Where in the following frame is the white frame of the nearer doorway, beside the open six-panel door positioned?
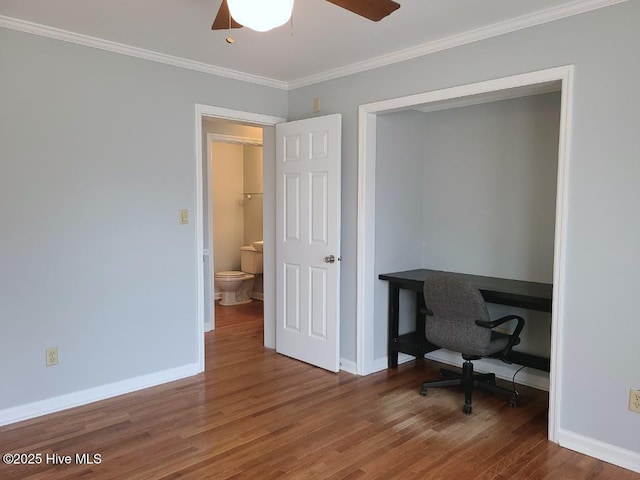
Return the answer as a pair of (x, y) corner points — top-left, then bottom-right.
(194, 104), (286, 372)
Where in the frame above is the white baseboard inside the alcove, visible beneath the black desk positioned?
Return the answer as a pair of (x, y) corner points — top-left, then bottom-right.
(373, 349), (549, 392)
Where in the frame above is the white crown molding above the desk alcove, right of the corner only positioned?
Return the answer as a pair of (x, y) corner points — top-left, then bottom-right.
(287, 0), (628, 90)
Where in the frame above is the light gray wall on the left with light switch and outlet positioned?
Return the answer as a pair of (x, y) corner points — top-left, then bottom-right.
(0, 29), (287, 410)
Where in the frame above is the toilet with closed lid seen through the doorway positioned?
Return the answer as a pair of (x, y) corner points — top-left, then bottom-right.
(213, 246), (262, 306)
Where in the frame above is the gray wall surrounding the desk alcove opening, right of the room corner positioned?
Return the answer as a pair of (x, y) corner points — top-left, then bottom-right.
(289, 1), (640, 452)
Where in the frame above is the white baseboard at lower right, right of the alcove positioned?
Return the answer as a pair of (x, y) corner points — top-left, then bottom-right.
(558, 428), (640, 473)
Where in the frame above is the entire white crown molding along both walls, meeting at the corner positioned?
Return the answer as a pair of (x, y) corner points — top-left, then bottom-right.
(0, 0), (628, 90)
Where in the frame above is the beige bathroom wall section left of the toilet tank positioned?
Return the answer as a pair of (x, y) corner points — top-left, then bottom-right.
(210, 142), (244, 272)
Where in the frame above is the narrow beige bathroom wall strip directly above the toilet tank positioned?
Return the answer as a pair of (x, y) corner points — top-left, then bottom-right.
(244, 145), (263, 245)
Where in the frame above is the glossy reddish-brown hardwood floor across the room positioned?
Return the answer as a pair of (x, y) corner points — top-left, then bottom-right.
(0, 302), (640, 480)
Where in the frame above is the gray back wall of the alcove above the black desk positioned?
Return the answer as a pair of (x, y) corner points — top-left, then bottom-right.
(422, 93), (560, 283)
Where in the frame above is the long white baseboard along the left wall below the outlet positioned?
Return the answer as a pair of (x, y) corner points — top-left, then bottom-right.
(0, 363), (200, 426)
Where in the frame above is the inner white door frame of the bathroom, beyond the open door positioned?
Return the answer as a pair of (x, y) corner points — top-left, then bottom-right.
(208, 133), (264, 332)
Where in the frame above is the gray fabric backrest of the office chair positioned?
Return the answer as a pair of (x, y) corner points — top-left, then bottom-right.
(424, 274), (491, 354)
